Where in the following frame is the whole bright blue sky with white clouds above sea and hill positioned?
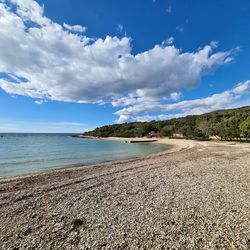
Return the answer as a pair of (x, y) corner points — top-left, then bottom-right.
(0, 0), (250, 133)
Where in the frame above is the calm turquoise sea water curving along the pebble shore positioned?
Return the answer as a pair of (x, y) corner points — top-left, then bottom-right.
(0, 134), (169, 177)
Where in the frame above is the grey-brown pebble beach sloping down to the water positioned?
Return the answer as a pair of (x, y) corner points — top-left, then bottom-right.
(0, 142), (250, 250)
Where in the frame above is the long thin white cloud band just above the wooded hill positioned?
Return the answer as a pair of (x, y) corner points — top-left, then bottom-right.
(115, 80), (250, 123)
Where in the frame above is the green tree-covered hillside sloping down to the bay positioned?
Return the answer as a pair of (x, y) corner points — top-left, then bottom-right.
(84, 106), (250, 140)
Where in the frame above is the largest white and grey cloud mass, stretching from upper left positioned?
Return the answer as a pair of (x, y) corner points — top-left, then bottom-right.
(0, 0), (245, 121)
